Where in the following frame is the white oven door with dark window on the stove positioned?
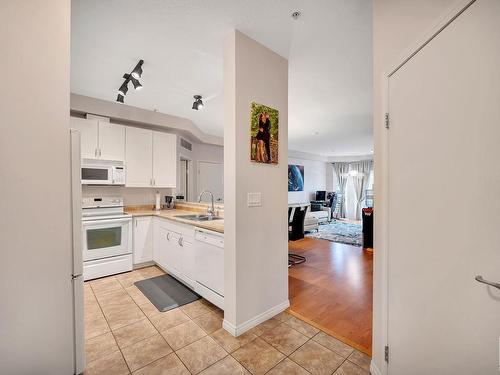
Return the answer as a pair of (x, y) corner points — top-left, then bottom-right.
(82, 217), (132, 261)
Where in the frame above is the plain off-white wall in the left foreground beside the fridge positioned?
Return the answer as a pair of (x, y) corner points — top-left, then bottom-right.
(0, 0), (73, 375)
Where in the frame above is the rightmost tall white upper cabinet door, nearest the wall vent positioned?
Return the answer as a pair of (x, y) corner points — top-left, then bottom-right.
(153, 131), (177, 188)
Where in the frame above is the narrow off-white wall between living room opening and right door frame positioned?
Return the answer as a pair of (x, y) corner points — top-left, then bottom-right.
(373, 0), (461, 373)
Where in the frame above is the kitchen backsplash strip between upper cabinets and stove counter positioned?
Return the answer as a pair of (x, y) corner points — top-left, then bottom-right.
(82, 185), (175, 206)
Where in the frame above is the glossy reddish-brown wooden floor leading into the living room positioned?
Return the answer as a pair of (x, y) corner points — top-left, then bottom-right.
(289, 238), (373, 355)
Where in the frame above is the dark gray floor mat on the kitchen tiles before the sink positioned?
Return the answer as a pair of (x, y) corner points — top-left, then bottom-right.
(134, 275), (200, 312)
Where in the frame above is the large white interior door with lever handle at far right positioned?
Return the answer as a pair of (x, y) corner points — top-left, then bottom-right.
(388, 0), (500, 375)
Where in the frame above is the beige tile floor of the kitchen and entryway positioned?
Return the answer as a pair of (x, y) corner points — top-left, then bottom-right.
(85, 267), (370, 375)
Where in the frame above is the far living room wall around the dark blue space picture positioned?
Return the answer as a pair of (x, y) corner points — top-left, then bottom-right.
(288, 158), (333, 203)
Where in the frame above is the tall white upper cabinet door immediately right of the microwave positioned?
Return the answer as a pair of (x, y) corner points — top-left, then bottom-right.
(125, 126), (153, 187)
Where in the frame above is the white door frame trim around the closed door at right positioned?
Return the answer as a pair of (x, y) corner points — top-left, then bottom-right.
(376, 0), (480, 375)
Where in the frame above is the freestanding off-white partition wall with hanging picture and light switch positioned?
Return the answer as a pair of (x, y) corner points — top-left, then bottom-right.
(224, 31), (289, 334)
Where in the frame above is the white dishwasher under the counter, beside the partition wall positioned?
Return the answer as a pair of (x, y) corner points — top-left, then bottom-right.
(194, 228), (224, 300)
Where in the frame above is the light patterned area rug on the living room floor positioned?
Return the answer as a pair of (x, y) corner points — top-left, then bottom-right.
(306, 220), (363, 246)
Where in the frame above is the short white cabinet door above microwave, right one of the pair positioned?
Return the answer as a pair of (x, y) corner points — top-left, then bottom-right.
(99, 122), (125, 161)
